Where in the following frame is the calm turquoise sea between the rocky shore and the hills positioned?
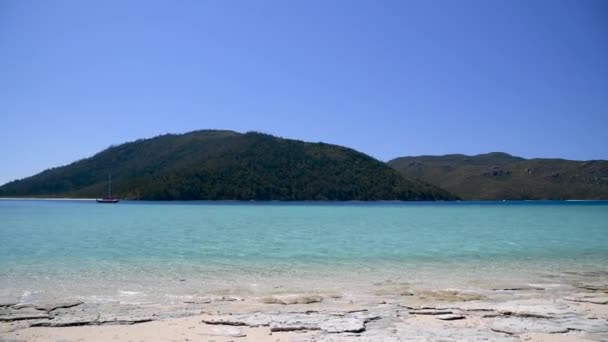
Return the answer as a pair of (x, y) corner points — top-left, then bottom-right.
(0, 200), (608, 303)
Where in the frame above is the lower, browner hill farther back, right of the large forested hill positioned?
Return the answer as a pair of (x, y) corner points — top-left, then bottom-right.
(388, 152), (608, 200)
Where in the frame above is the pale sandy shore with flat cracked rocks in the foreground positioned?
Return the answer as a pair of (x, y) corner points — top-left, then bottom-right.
(0, 276), (608, 342)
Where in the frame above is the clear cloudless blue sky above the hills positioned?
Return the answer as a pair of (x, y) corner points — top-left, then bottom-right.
(0, 0), (608, 183)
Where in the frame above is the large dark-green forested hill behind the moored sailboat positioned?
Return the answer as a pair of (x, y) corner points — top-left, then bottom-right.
(0, 130), (454, 200)
